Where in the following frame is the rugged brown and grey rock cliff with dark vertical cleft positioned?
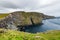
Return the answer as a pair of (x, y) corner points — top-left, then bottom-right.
(0, 11), (54, 30)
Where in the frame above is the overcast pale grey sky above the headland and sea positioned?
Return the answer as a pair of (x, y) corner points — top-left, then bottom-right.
(0, 0), (60, 16)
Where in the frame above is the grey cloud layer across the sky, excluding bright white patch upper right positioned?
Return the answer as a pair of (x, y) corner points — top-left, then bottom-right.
(0, 0), (60, 16)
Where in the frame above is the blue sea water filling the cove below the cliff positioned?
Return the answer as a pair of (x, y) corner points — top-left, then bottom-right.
(25, 19), (60, 33)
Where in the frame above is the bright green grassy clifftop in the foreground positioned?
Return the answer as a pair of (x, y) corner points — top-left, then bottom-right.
(0, 29), (60, 40)
